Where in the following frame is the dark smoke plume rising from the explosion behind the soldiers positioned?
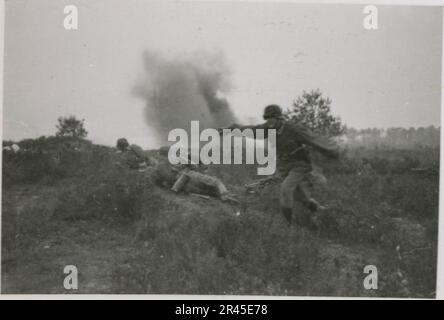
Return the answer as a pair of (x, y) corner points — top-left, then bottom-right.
(135, 52), (235, 144)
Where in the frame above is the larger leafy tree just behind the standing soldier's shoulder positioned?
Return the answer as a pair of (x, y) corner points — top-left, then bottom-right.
(286, 89), (346, 137)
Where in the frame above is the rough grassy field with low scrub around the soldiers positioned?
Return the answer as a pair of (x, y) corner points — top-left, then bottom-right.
(2, 138), (439, 297)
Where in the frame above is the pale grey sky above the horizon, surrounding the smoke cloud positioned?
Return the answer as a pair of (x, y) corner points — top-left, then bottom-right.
(3, 0), (442, 148)
